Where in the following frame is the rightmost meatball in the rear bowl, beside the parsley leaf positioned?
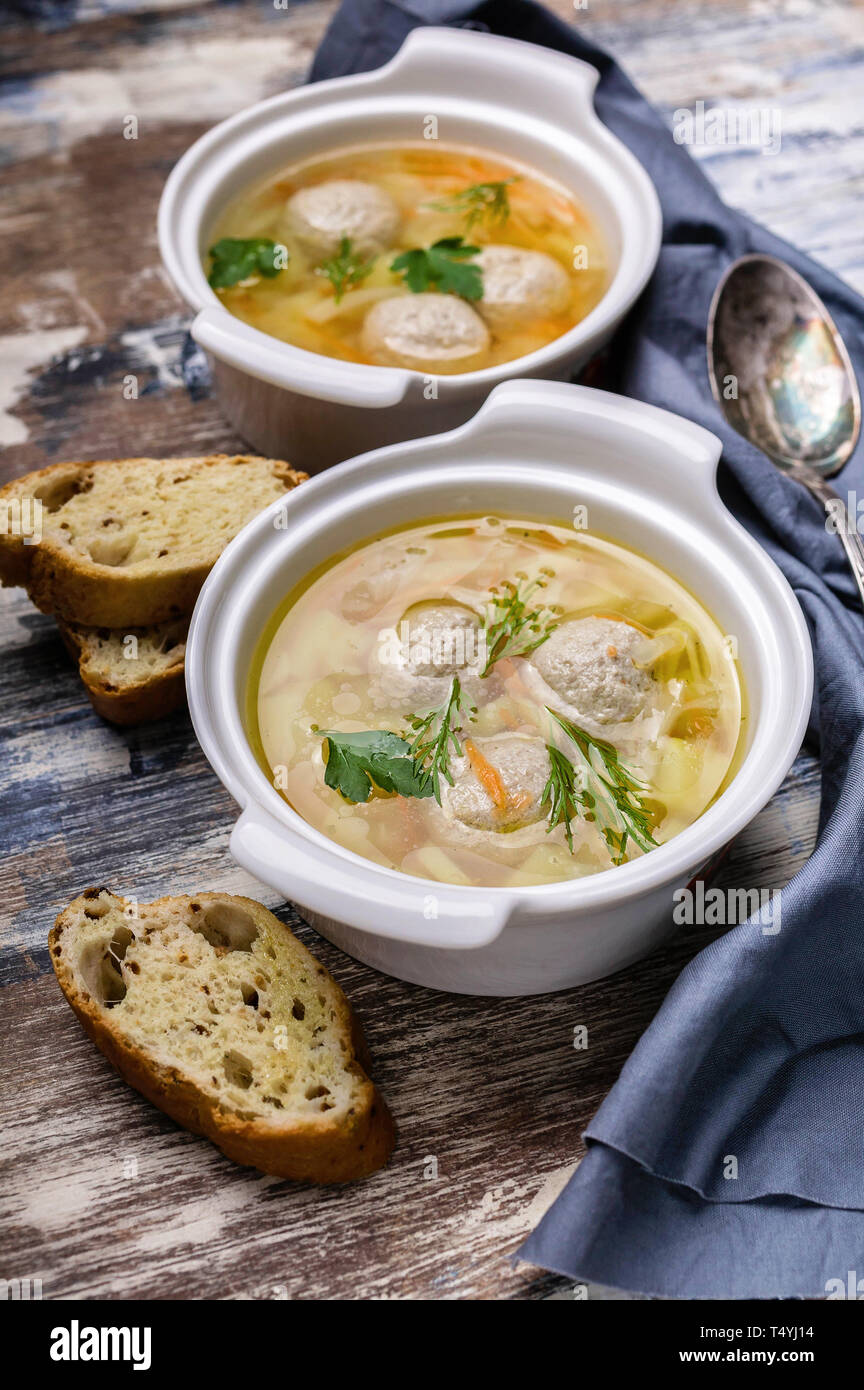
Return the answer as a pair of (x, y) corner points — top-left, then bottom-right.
(476, 246), (570, 331)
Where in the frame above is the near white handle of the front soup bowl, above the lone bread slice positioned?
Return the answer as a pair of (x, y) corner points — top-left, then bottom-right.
(231, 803), (514, 951)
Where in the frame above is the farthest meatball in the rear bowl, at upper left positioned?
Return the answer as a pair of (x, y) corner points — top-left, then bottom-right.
(285, 178), (401, 261)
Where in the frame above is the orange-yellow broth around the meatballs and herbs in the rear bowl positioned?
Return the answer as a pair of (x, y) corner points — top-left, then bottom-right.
(211, 143), (608, 373)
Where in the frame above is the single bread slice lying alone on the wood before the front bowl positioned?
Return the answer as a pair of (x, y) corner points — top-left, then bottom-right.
(49, 888), (394, 1183)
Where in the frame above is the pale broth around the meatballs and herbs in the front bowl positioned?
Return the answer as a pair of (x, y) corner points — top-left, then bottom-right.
(249, 516), (743, 887)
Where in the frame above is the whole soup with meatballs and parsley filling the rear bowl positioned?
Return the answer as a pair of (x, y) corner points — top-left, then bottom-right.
(206, 142), (608, 374)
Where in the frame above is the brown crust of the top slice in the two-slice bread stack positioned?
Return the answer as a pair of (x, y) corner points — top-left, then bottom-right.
(0, 455), (307, 627)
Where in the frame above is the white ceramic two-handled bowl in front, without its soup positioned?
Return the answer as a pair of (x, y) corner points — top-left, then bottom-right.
(186, 381), (813, 995)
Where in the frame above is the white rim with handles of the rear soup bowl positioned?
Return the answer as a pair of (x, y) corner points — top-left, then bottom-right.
(158, 26), (663, 406)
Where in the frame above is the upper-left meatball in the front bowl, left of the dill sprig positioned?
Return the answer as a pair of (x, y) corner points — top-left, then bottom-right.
(372, 602), (482, 713)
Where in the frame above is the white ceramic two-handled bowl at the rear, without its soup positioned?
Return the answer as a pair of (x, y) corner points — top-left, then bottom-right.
(158, 29), (661, 473)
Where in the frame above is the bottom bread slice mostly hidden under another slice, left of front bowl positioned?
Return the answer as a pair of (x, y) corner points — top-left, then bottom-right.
(57, 617), (189, 724)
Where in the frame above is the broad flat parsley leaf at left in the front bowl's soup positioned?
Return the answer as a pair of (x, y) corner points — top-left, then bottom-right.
(313, 728), (432, 802)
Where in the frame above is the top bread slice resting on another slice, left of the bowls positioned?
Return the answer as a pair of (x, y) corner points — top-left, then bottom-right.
(0, 453), (306, 630)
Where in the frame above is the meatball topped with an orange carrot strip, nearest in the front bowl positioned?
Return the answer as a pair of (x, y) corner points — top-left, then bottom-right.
(442, 734), (549, 831)
